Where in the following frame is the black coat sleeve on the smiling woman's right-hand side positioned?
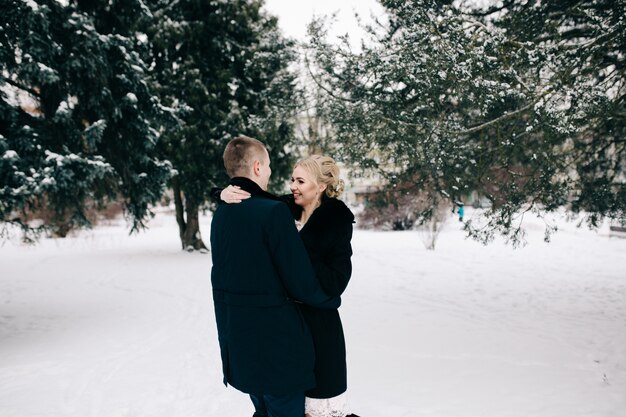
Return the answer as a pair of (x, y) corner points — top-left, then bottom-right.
(313, 222), (352, 297)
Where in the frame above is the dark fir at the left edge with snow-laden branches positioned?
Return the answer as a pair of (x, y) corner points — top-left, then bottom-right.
(0, 0), (171, 239)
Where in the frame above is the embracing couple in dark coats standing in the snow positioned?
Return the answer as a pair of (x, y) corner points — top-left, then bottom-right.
(211, 136), (356, 417)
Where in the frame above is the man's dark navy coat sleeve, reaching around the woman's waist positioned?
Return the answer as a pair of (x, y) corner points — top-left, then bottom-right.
(265, 204), (341, 308)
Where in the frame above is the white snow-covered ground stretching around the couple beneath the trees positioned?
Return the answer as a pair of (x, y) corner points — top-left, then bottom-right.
(0, 213), (626, 417)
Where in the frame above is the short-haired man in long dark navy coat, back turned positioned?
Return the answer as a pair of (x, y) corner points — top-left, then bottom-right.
(211, 136), (339, 417)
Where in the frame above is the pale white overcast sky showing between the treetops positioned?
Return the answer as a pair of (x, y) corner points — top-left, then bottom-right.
(265, 0), (383, 40)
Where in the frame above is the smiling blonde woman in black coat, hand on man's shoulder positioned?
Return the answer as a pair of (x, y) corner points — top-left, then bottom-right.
(220, 155), (356, 417)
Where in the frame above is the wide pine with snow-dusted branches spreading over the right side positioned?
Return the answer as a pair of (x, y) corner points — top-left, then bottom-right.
(309, 0), (626, 242)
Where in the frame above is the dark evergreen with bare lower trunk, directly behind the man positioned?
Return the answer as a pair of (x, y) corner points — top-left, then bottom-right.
(145, 0), (298, 250)
